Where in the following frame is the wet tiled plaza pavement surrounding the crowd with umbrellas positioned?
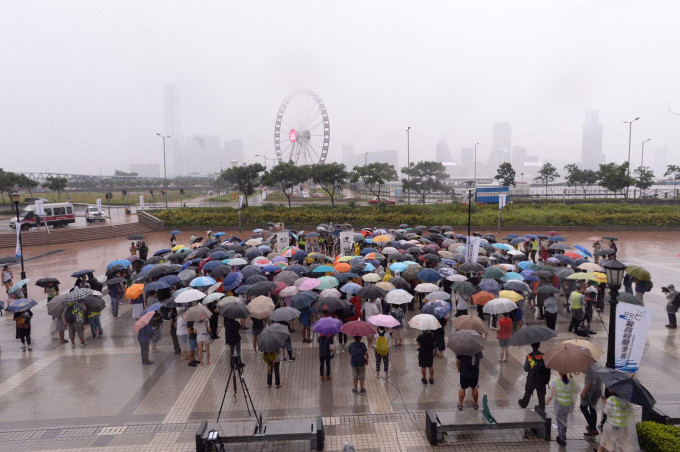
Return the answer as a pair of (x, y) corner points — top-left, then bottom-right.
(0, 230), (680, 451)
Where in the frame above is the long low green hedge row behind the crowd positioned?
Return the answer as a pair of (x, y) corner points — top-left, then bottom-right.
(153, 203), (680, 227)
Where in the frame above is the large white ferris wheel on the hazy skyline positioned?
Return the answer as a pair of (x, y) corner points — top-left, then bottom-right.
(274, 89), (331, 165)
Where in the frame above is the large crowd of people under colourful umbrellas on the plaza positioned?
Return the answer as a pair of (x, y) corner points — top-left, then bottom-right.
(3, 225), (668, 450)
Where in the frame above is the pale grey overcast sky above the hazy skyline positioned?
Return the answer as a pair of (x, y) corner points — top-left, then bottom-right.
(0, 0), (680, 174)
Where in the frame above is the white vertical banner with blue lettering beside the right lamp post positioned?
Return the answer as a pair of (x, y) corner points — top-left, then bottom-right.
(614, 302), (652, 373)
